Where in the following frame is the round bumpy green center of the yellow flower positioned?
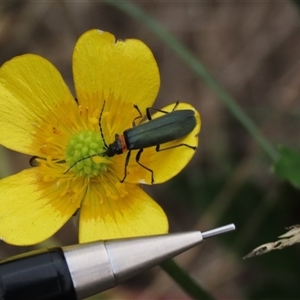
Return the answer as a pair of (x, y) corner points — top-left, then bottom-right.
(66, 131), (107, 177)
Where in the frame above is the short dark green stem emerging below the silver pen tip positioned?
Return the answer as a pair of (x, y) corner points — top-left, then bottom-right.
(160, 259), (214, 300)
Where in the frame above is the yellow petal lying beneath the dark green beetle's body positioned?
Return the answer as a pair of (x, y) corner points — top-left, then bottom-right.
(118, 102), (201, 184)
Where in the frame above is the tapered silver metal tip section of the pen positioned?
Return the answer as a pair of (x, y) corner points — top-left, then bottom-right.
(63, 224), (235, 299)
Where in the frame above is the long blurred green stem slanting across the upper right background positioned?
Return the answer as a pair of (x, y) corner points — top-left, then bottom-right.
(104, 0), (279, 160)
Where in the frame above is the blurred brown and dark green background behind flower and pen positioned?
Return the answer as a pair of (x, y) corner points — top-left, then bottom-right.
(0, 0), (300, 299)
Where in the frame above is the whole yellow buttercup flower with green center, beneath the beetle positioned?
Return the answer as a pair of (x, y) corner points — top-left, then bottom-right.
(0, 30), (200, 245)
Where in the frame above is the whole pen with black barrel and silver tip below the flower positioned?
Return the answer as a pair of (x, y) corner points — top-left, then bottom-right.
(0, 224), (235, 300)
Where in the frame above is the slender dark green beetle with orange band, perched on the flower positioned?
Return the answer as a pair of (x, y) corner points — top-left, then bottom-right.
(95, 101), (197, 184)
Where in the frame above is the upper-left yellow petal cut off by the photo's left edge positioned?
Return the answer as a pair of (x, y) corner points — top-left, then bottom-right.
(0, 54), (76, 155)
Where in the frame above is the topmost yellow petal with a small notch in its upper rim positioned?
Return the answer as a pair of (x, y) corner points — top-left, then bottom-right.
(73, 29), (160, 113)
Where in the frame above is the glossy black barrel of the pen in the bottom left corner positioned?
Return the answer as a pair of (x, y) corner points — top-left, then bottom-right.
(0, 248), (76, 300)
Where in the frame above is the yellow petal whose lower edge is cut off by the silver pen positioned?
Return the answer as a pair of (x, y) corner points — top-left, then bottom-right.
(79, 184), (168, 243)
